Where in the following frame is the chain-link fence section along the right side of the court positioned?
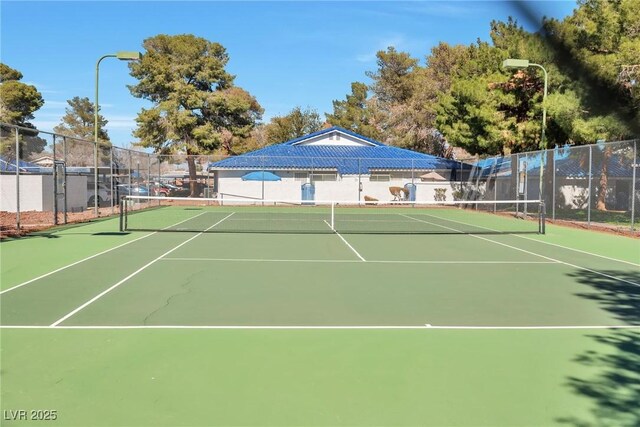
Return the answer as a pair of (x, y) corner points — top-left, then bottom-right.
(462, 140), (640, 232)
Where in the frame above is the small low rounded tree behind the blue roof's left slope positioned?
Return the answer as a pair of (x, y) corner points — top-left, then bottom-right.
(266, 106), (323, 145)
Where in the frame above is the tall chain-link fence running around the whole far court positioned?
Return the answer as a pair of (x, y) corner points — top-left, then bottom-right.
(0, 124), (640, 234)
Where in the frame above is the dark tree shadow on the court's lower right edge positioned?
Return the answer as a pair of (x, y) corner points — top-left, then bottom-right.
(557, 270), (640, 427)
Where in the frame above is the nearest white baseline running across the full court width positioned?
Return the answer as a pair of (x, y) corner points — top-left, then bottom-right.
(0, 324), (640, 331)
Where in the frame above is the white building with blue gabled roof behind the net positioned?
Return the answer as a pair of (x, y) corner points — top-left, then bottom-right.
(208, 126), (471, 201)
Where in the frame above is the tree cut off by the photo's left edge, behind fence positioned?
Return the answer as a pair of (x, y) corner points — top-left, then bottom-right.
(0, 63), (47, 159)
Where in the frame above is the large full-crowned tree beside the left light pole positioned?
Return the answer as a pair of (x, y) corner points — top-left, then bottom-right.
(129, 34), (263, 196)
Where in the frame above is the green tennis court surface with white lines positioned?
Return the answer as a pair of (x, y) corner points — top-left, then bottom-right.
(0, 206), (640, 426)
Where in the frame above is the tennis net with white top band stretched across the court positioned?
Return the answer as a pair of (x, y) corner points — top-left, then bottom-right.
(120, 196), (545, 234)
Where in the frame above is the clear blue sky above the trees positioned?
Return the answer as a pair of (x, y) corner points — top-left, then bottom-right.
(0, 0), (575, 147)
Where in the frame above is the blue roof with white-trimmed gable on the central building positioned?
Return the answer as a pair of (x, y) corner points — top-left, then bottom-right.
(208, 127), (471, 175)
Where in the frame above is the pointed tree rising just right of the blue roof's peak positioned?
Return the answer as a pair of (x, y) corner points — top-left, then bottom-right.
(325, 82), (381, 139)
